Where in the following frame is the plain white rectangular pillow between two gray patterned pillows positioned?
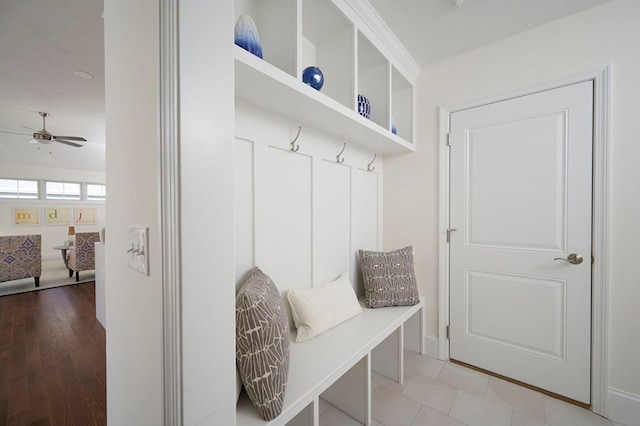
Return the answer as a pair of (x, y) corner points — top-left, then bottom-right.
(287, 273), (362, 342)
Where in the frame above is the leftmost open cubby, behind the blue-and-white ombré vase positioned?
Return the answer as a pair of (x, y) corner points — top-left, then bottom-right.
(235, 0), (298, 77)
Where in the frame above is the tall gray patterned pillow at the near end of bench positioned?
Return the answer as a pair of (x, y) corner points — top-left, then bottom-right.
(236, 267), (289, 420)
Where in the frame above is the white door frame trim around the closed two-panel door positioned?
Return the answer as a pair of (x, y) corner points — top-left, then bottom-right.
(438, 65), (611, 417)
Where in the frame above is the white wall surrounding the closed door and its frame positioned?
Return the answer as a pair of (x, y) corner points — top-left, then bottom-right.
(384, 0), (640, 419)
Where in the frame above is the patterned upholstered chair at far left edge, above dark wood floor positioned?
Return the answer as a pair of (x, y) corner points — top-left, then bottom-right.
(0, 235), (42, 287)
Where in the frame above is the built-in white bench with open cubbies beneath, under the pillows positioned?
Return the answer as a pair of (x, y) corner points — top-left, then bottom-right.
(236, 299), (424, 426)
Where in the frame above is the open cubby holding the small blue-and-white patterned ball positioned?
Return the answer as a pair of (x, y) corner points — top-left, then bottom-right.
(356, 32), (391, 130)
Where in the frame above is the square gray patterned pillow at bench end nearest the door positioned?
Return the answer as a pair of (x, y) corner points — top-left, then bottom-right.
(358, 246), (420, 308)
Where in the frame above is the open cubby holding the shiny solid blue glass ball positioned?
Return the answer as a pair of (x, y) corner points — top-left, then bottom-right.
(298, 0), (355, 109)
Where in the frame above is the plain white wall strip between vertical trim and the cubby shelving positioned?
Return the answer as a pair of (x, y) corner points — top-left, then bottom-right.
(179, 0), (235, 426)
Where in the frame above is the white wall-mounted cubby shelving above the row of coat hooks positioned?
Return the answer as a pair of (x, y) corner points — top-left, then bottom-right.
(235, 0), (415, 154)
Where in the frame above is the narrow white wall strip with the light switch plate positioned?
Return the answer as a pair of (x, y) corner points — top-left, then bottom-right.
(105, 0), (164, 425)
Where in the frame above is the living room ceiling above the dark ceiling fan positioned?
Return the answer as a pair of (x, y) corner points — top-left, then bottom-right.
(0, 0), (105, 173)
